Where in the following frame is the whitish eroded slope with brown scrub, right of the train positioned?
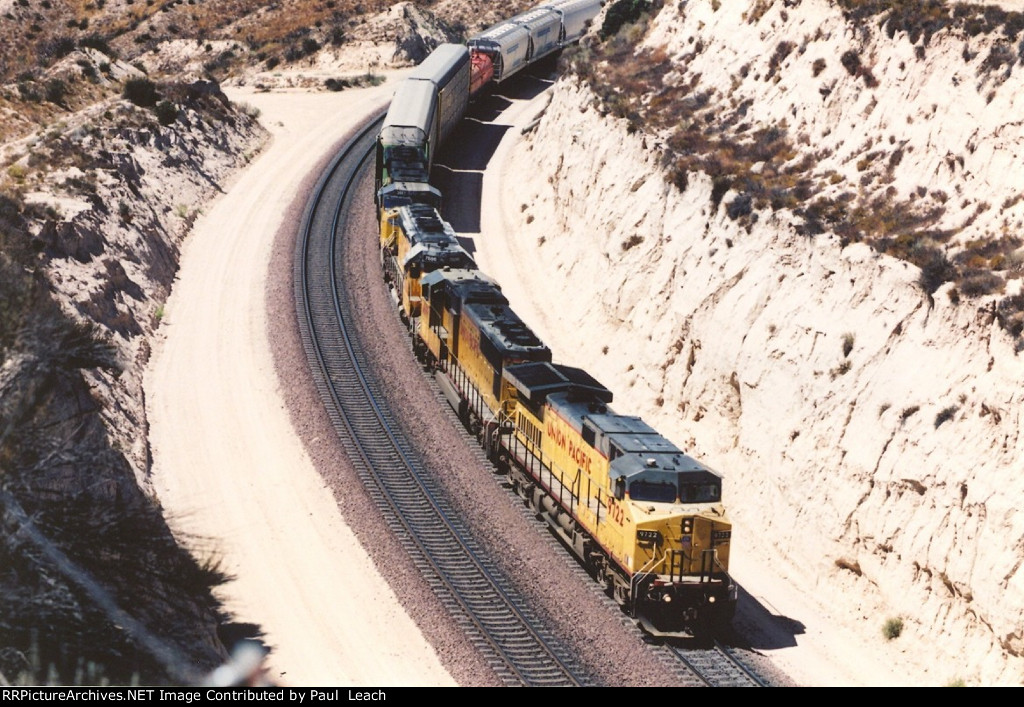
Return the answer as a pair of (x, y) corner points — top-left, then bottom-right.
(487, 0), (1024, 684)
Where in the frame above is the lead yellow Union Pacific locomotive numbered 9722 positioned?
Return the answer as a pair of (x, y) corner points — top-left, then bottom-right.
(497, 363), (737, 635)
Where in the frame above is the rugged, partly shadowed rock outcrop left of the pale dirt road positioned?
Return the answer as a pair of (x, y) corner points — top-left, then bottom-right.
(0, 74), (264, 683)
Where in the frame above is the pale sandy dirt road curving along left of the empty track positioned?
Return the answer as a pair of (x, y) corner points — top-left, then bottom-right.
(146, 85), (454, 685)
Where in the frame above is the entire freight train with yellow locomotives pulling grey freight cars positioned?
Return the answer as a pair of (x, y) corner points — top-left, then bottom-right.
(376, 0), (737, 636)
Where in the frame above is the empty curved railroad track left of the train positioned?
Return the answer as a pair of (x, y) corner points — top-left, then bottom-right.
(295, 116), (588, 687)
